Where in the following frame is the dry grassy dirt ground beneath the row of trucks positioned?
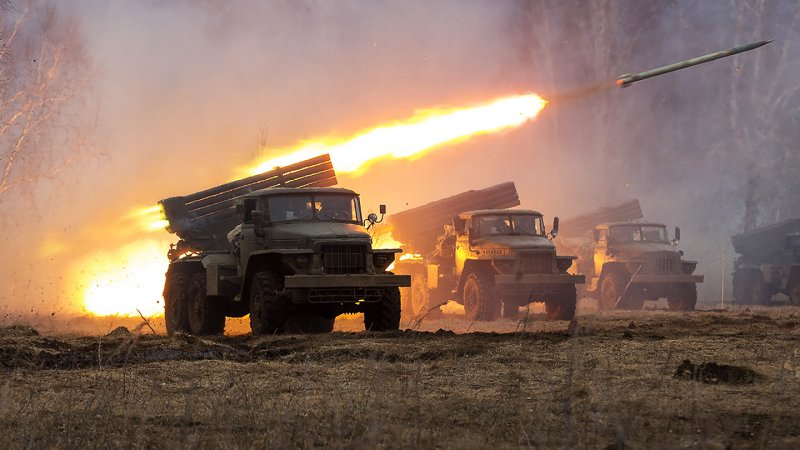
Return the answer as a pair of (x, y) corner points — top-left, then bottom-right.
(0, 305), (800, 449)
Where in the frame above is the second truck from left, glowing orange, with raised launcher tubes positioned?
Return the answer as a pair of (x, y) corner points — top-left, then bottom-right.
(392, 183), (584, 321)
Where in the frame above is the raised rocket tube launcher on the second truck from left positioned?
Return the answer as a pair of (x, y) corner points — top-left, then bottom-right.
(389, 181), (519, 254)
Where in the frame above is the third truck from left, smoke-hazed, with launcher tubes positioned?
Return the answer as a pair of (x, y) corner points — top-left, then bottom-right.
(559, 200), (703, 311)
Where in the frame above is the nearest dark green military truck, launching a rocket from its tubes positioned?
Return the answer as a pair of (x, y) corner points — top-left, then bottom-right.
(159, 155), (410, 335)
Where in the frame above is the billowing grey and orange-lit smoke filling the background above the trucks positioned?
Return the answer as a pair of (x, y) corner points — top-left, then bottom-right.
(0, 0), (800, 313)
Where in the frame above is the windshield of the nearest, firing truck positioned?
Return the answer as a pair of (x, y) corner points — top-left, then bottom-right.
(268, 194), (361, 223)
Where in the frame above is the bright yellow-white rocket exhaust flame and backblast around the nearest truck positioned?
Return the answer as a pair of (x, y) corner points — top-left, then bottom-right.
(76, 94), (547, 316)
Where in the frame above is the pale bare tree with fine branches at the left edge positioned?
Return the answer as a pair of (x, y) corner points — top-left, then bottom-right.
(0, 0), (94, 198)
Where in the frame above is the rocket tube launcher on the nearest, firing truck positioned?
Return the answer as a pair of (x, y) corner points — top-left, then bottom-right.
(158, 155), (336, 250)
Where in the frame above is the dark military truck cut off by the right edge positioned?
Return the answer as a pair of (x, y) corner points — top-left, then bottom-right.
(732, 219), (800, 305)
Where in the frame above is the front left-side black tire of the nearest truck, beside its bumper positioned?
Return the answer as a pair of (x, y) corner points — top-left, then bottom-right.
(250, 270), (289, 336)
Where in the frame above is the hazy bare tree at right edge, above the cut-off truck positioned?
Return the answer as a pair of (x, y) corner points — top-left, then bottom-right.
(728, 0), (800, 231)
